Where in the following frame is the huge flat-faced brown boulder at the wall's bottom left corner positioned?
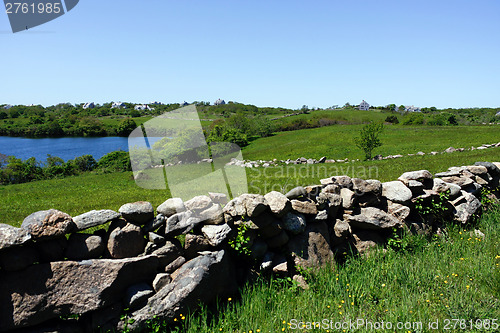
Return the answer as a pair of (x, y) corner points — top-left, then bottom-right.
(0, 256), (158, 332)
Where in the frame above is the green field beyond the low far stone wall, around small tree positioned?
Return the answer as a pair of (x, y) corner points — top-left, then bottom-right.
(243, 124), (500, 160)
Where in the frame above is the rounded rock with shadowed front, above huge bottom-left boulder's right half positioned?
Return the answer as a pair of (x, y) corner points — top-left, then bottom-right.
(107, 223), (146, 259)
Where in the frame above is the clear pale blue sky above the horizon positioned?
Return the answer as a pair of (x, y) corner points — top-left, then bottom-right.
(0, 0), (500, 108)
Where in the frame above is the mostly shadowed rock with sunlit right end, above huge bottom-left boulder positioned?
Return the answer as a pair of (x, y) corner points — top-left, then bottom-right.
(66, 234), (106, 260)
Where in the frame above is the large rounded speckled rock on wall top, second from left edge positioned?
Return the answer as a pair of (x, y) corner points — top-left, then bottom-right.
(21, 209), (76, 240)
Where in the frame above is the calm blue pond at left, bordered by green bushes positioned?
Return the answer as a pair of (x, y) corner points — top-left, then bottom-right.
(0, 136), (145, 161)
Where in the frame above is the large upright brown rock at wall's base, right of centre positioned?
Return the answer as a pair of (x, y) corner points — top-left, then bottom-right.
(287, 222), (334, 268)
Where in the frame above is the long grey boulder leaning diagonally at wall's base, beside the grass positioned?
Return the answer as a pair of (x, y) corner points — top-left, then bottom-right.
(122, 251), (237, 332)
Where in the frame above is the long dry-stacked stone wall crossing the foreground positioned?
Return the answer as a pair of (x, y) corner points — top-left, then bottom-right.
(0, 162), (500, 332)
